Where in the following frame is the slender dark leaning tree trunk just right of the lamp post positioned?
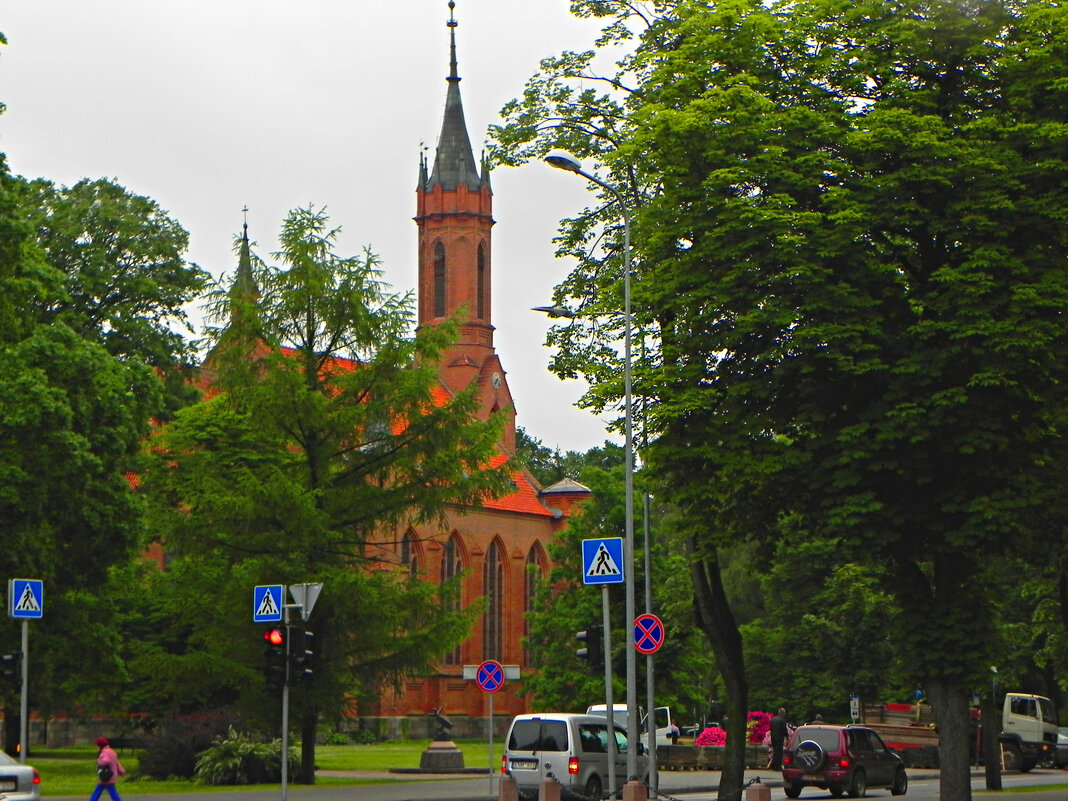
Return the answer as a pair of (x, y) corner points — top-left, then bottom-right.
(687, 537), (749, 801)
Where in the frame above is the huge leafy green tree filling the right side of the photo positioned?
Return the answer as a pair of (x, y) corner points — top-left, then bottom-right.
(499, 0), (1068, 799)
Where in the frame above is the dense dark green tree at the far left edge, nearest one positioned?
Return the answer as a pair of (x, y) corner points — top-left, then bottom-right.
(0, 158), (179, 734)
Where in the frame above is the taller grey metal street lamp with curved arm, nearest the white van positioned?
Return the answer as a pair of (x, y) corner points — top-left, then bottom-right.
(545, 153), (636, 782)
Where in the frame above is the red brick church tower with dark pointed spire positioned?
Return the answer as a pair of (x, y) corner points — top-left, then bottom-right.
(414, 0), (515, 452)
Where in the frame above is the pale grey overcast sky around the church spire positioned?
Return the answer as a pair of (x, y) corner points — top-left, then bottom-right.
(0, 0), (615, 451)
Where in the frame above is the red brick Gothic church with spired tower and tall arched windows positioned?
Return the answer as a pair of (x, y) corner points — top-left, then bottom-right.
(360, 2), (588, 735)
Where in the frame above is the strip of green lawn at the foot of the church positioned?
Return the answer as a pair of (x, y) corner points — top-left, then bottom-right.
(28, 740), (501, 797)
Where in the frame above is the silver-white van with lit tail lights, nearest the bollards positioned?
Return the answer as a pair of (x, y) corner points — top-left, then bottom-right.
(501, 712), (648, 799)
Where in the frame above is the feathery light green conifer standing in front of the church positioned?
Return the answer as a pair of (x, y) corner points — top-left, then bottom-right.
(145, 208), (507, 782)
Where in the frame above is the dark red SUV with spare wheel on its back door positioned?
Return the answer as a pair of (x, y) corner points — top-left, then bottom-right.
(783, 725), (909, 798)
